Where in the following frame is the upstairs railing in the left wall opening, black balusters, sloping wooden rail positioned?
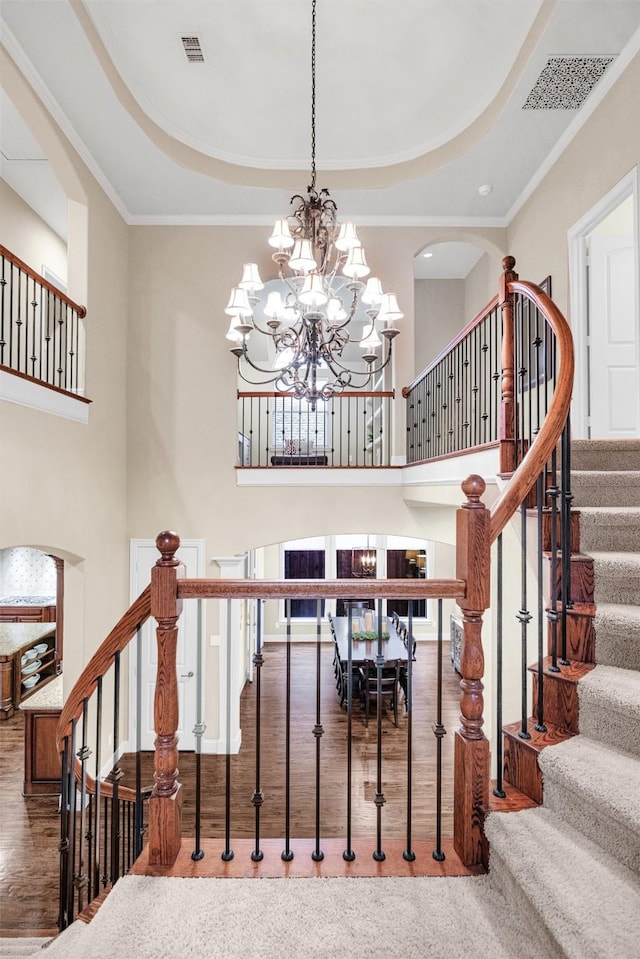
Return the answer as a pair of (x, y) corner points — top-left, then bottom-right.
(0, 246), (87, 396)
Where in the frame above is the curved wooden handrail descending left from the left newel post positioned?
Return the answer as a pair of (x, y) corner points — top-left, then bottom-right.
(56, 586), (151, 801)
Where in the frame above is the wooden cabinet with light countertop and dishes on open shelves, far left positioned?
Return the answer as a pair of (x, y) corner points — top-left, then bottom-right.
(0, 622), (60, 720)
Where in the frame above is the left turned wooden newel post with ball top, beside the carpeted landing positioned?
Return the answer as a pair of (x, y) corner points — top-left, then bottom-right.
(149, 530), (185, 866)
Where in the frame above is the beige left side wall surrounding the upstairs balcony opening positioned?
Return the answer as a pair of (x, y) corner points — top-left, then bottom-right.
(0, 48), (129, 688)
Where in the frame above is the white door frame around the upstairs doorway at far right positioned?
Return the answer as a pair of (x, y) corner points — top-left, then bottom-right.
(567, 166), (640, 439)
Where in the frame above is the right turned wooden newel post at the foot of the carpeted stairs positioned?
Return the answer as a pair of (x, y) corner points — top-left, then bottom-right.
(453, 476), (490, 866)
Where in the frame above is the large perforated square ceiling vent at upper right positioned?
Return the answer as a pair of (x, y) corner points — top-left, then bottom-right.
(522, 57), (615, 110)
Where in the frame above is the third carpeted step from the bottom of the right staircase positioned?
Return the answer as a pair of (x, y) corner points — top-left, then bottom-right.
(578, 666), (640, 757)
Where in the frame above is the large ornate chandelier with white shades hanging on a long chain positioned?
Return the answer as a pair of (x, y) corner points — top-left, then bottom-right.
(225, 0), (404, 410)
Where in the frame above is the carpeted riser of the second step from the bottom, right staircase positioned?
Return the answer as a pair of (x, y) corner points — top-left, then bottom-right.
(544, 773), (640, 873)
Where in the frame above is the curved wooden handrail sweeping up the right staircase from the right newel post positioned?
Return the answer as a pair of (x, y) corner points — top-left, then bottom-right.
(489, 280), (574, 543)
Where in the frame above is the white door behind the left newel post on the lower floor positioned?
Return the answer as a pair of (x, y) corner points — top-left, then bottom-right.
(131, 540), (204, 750)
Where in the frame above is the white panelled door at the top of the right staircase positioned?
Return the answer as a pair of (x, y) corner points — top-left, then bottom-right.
(588, 234), (640, 439)
